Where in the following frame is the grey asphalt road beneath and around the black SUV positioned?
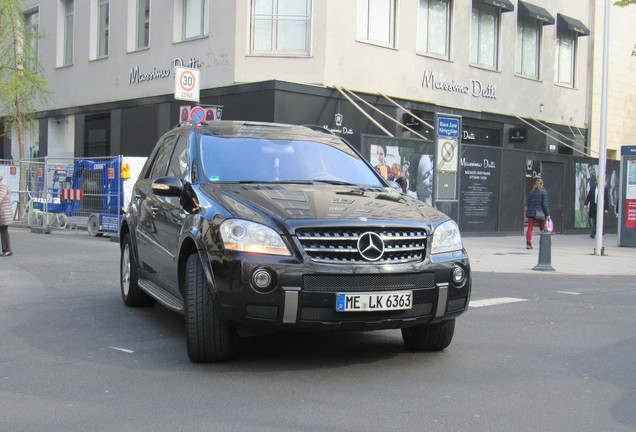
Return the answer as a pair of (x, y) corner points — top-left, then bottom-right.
(0, 229), (636, 432)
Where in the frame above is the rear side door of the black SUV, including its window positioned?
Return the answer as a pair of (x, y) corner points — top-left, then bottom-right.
(133, 135), (176, 279)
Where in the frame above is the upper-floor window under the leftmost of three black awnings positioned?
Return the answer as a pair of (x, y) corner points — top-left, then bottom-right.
(470, 3), (500, 69)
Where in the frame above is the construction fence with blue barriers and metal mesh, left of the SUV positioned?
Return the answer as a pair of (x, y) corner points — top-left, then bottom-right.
(0, 156), (146, 236)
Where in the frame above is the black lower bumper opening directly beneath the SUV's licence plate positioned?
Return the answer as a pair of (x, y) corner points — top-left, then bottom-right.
(300, 303), (433, 322)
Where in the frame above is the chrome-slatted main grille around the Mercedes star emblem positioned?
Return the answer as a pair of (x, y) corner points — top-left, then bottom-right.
(296, 228), (426, 264)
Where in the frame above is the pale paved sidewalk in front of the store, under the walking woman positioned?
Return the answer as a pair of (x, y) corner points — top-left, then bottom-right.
(462, 234), (636, 276)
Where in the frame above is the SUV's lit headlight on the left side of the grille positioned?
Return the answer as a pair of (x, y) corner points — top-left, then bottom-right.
(221, 219), (291, 256)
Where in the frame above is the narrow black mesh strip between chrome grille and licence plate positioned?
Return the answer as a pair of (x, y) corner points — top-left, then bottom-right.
(303, 273), (435, 292)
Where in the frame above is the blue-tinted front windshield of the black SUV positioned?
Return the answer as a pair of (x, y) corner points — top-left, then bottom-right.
(200, 135), (382, 186)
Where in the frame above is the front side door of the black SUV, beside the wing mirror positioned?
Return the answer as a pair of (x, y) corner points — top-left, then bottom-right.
(152, 135), (189, 296)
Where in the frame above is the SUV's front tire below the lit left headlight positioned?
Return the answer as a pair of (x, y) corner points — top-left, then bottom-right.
(185, 254), (234, 363)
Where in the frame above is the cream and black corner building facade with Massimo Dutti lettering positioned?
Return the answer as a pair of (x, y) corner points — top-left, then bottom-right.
(0, 0), (628, 232)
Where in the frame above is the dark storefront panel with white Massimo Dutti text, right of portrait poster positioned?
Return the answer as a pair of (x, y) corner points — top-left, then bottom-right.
(459, 146), (501, 232)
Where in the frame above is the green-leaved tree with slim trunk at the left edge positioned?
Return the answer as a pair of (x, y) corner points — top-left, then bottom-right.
(0, 0), (51, 217)
